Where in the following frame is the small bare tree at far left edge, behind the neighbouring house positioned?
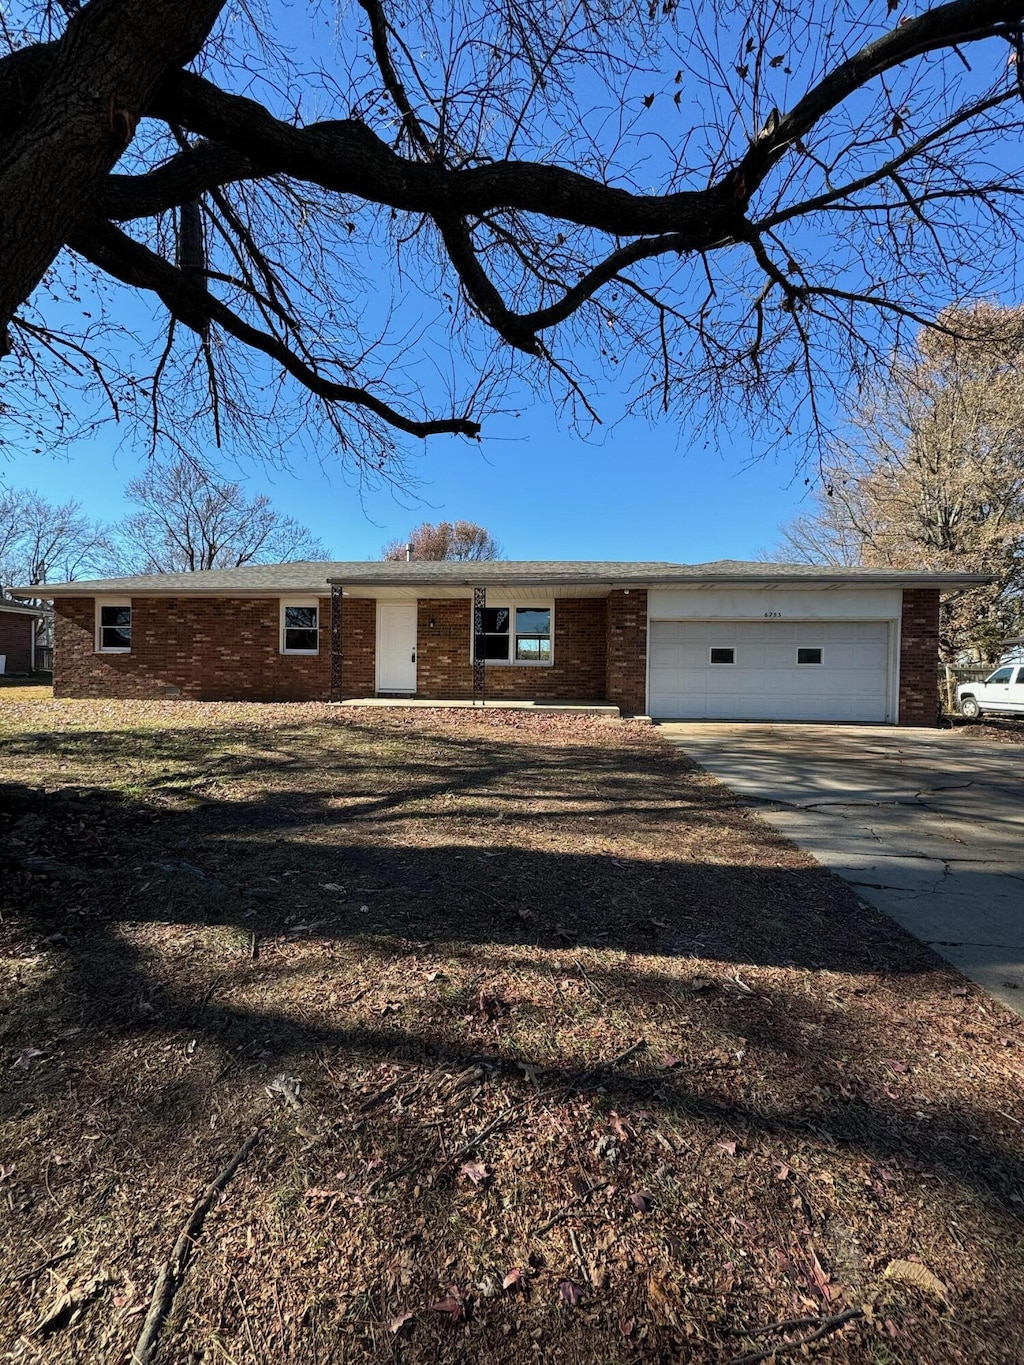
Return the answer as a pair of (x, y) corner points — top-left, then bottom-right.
(0, 489), (115, 587)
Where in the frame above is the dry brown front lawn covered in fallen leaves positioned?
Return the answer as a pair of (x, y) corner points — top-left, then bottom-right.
(0, 692), (1024, 1365)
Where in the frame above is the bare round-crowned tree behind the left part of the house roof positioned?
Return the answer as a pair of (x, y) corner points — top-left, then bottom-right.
(116, 460), (328, 573)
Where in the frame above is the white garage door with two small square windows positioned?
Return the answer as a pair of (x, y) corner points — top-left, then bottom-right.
(649, 621), (890, 723)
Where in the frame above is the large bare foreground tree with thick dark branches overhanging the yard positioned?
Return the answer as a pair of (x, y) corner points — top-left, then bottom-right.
(0, 0), (1024, 471)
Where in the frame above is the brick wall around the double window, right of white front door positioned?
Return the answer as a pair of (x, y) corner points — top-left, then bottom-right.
(416, 598), (606, 702)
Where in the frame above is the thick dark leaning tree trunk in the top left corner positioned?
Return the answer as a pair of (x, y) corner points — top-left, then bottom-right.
(0, 0), (224, 341)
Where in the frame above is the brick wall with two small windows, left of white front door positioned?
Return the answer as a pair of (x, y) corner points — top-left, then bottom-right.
(53, 597), (363, 702)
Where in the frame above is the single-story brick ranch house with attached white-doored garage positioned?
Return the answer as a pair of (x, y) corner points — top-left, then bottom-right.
(10, 560), (987, 725)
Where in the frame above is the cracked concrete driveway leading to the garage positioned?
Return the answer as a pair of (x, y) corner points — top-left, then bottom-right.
(659, 722), (1024, 1014)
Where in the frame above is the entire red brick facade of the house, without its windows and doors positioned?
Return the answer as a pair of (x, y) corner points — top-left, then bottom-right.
(52, 588), (938, 725)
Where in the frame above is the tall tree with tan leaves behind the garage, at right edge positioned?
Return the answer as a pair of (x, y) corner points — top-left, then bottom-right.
(777, 303), (1024, 663)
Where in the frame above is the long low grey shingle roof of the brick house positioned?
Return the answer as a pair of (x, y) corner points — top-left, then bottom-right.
(11, 560), (989, 598)
